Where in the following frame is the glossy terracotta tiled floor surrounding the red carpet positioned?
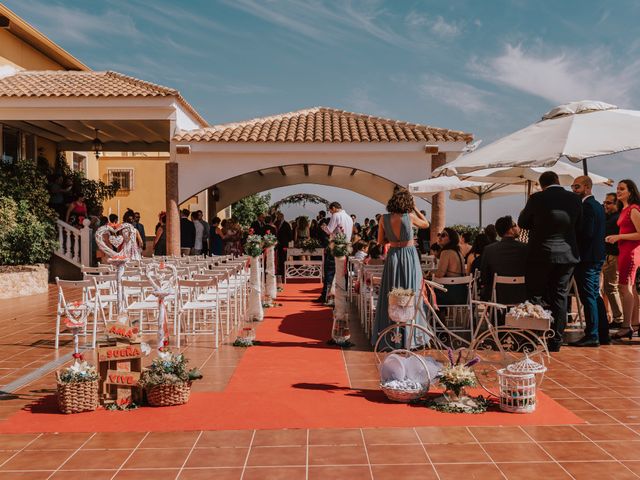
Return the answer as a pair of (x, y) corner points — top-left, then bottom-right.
(0, 284), (640, 480)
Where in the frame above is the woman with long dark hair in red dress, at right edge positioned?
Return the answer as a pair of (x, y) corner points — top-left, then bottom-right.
(605, 180), (640, 338)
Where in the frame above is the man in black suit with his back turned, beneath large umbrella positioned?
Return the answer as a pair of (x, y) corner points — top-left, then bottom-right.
(518, 171), (582, 352)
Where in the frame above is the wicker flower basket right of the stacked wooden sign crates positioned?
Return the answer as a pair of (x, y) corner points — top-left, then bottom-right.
(138, 351), (202, 407)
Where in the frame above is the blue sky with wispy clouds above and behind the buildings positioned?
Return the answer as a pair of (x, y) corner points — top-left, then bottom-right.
(5, 0), (640, 223)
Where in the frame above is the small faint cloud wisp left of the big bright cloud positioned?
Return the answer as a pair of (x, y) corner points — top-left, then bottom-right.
(418, 75), (495, 113)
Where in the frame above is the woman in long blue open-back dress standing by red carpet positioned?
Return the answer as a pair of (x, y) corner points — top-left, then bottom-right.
(371, 188), (429, 348)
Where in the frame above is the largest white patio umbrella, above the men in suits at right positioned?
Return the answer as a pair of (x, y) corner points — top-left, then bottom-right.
(434, 100), (640, 176)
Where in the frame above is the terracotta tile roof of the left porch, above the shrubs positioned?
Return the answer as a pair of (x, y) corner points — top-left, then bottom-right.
(0, 70), (208, 126)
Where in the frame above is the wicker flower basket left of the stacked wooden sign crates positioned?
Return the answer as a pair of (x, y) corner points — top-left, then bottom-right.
(56, 358), (98, 413)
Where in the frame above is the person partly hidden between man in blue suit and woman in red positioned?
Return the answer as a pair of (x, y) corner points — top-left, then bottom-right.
(602, 193), (623, 328)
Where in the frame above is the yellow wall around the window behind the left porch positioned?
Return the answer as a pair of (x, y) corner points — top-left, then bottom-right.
(97, 156), (168, 237)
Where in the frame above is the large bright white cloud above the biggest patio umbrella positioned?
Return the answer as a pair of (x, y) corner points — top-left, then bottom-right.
(468, 45), (640, 106)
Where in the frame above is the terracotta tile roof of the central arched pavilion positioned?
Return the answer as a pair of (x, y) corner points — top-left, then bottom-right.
(174, 107), (473, 143)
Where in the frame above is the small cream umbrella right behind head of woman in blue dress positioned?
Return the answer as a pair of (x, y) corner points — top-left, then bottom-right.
(409, 177), (524, 227)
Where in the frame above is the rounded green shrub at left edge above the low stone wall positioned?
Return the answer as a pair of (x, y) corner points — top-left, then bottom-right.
(0, 197), (57, 265)
